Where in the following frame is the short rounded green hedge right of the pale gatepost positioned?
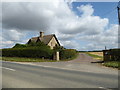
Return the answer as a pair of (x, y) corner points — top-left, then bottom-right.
(60, 49), (77, 60)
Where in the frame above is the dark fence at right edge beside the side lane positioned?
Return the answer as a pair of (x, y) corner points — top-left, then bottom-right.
(103, 49), (120, 61)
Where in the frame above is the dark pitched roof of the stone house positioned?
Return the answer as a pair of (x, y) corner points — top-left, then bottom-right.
(28, 34), (60, 45)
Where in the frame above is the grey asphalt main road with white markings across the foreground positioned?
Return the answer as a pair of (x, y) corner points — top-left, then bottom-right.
(2, 61), (118, 89)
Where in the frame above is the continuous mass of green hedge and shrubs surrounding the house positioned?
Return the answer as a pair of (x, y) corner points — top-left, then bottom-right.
(2, 42), (77, 60)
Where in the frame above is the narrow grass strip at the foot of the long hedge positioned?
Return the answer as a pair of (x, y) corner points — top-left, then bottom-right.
(2, 57), (56, 62)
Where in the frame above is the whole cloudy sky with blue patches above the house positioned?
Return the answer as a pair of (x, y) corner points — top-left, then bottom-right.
(0, 0), (118, 50)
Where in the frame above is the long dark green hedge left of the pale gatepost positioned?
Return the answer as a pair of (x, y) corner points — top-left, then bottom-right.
(2, 46), (53, 59)
